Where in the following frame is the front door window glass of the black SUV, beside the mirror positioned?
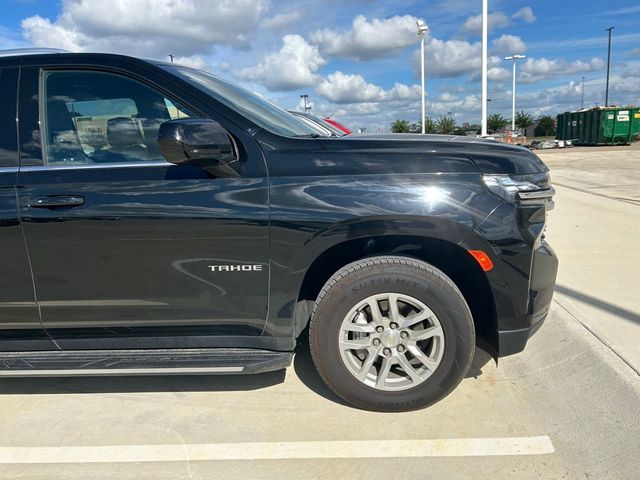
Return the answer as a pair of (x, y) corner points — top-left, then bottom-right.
(44, 71), (190, 165)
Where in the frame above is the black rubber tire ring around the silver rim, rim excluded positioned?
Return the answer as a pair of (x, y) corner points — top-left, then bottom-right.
(312, 264), (475, 411)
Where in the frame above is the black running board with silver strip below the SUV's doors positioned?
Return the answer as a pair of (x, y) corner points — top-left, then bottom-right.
(0, 348), (293, 377)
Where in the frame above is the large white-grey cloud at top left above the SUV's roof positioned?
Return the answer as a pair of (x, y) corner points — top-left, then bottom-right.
(21, 0), (268, 58)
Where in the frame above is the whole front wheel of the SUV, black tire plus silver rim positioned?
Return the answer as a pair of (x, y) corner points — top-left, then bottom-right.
(309, 256), (475, 412)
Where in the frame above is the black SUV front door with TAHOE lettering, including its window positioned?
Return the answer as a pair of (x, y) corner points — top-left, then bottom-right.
(19, 66), (269, 348)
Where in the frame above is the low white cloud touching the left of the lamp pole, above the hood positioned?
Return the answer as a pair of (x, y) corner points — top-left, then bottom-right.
(316, 71), (421, 103)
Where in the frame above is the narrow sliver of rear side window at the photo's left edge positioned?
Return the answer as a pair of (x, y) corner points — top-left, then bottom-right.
(0, 68), (18, 167)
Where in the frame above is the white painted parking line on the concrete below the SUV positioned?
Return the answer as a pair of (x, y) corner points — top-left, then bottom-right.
(0, 435), (555, 464)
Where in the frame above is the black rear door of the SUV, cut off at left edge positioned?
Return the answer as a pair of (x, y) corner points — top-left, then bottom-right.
(0, 67), (55, 351)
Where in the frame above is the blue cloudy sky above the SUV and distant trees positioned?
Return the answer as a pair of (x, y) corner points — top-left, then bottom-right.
(0, 0), (640, 132)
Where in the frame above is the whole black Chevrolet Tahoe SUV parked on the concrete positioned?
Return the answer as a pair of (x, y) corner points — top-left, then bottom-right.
(0, 51), (557, 411)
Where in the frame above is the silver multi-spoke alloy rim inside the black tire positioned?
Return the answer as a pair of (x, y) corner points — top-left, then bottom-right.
(338, 293), (445, 391)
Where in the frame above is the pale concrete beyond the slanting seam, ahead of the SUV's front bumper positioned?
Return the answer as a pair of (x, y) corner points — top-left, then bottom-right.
(539, 144), (640, 373)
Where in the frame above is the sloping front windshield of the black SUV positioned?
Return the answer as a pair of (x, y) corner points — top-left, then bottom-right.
(161, 65), (328, 137)
